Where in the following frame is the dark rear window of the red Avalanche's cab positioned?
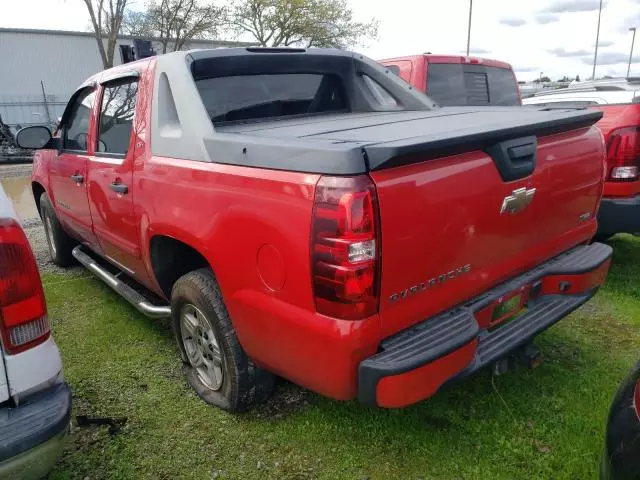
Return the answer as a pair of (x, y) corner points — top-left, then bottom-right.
(196, 73), (348, 123)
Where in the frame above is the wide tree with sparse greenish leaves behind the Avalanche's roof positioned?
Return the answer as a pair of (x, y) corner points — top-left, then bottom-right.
(232, 0), (379, 48)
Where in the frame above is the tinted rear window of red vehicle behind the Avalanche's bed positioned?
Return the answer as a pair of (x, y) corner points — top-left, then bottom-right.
(427, 63), (520, 106)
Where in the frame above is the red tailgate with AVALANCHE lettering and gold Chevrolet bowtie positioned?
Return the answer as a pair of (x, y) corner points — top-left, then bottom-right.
(371, 127), (604, 333)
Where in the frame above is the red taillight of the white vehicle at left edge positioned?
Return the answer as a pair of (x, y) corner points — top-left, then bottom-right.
(0, 220), (49, 354)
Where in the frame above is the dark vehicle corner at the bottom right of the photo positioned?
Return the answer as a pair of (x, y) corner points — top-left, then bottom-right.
(600, 362), (640, 480)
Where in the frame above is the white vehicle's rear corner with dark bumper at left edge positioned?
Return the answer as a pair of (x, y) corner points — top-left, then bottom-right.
(0, 183), (71, 480)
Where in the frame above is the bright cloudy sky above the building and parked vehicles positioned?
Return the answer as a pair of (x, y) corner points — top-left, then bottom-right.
(0, 0), (640, 80)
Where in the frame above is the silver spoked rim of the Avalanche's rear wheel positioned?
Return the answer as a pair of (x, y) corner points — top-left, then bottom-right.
(180, 303), (223, 390)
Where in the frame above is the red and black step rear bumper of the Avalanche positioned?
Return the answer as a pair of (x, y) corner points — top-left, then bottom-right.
(358, 243), (612, 408)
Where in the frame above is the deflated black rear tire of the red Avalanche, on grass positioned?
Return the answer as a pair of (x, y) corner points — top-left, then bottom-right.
(171, 268), (274, 412)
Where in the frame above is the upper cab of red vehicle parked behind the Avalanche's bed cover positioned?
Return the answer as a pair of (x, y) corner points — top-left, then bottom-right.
(380, 53), (522, 107)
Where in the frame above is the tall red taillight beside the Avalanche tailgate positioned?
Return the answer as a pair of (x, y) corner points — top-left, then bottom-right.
(311, 176), (380, 320)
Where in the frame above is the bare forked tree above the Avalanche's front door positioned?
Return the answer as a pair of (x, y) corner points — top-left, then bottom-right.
(83, 0), (129, 68)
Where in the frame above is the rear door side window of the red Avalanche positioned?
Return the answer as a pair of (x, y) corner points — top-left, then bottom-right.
(96, 79), (138, 155)
